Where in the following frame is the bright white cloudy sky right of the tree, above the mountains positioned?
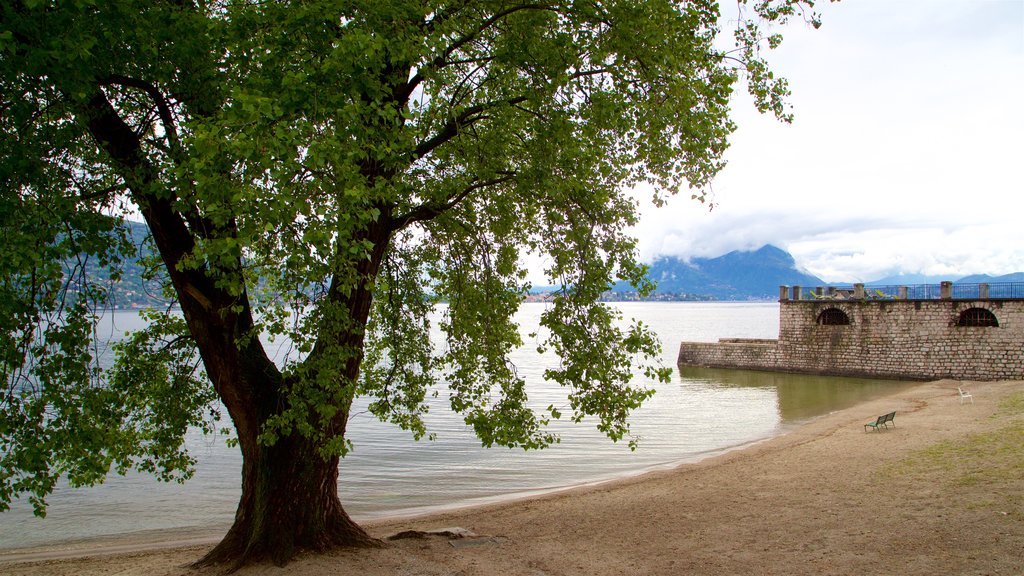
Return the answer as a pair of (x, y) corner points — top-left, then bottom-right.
(635, 0), (1024, 282)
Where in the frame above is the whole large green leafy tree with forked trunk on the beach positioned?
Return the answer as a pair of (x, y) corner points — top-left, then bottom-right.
(0, 0), (816, 565)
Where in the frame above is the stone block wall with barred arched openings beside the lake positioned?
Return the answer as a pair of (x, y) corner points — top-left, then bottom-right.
(679, 293), (1024, 380)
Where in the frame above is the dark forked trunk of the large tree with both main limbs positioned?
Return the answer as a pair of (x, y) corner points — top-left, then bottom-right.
(75, 81), (393, 568)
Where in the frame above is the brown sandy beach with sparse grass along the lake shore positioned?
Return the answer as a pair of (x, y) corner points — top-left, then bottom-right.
(0, 380), (1024, 576)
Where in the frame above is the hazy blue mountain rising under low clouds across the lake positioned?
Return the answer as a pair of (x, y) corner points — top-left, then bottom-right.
(615, 244), (825, 300)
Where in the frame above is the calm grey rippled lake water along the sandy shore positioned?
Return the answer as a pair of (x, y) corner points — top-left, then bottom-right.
(0, 302), (913, 548)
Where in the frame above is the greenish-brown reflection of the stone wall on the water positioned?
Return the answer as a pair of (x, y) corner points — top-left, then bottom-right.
(679, 367), (915, 424)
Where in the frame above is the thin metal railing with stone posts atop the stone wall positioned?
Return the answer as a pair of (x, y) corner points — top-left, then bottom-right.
(779, 282), (1024, 301)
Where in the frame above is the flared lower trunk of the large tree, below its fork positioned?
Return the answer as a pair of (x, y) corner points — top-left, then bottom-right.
(196, 426), (380, 567)
